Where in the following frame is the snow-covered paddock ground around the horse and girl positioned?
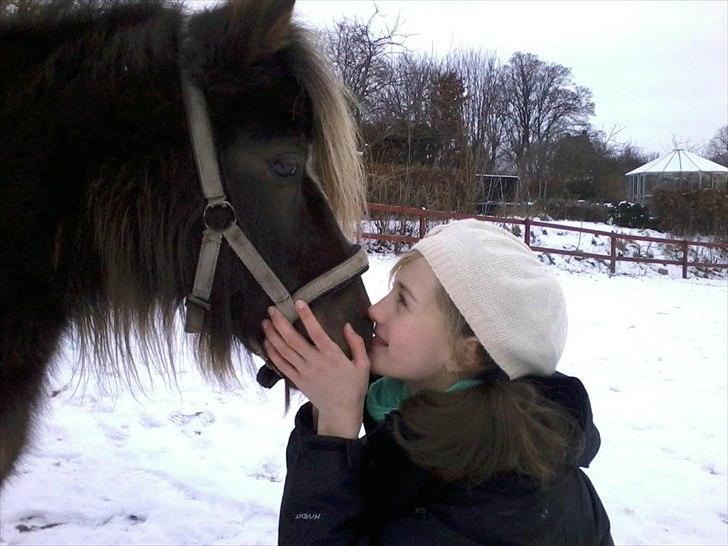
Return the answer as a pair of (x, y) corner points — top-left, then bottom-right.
(0, 249), (728, 545)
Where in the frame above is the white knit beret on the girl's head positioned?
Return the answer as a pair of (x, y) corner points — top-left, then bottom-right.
(412, 219), (567, 379)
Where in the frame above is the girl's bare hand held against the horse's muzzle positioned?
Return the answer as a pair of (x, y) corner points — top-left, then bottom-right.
(263, 301), (370, 438)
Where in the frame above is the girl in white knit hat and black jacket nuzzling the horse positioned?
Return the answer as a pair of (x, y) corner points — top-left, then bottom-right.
(263, 220), (612, 545)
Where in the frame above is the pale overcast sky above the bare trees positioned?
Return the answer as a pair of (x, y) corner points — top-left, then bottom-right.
(295, 0), (728, 153)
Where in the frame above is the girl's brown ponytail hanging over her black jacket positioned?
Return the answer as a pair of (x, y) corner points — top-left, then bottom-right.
(395, 370), (580, 484)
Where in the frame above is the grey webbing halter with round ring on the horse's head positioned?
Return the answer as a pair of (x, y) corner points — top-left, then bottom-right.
(181, 70), (369, 388)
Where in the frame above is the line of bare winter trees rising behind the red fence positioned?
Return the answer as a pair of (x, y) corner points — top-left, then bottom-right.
(320, 10), (719, 209)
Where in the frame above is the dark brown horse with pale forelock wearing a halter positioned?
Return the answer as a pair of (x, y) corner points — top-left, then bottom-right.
(0, 0), (372, 484)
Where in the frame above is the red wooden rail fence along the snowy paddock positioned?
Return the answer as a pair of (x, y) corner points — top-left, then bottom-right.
(361, 203), (728, 279)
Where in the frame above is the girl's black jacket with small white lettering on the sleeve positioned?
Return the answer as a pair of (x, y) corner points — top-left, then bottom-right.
(278, 373), (613, 546)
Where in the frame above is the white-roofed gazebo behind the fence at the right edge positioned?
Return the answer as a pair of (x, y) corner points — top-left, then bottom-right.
(625, 148), (728, 205)
